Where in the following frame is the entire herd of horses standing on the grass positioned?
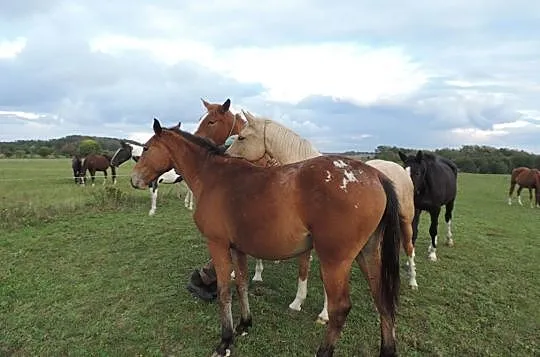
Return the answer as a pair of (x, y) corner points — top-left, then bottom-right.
(67, 99), (540, 356)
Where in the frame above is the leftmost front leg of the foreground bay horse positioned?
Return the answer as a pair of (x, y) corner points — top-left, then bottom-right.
(207, 241), (235, 357)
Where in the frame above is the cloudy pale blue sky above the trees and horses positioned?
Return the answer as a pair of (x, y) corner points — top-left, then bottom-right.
(0, 0), (540, 153)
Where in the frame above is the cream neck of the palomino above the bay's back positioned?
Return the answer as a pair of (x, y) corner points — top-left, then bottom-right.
(263, 121), (321, 165)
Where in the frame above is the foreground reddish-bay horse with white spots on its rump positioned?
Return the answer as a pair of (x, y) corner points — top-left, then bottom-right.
(131, 120), (401, 357)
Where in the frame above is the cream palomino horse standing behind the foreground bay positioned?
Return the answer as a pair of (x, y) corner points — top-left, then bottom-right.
(226, 112), (418, 324)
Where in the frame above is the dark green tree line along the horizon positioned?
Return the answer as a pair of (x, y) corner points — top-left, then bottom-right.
(0, 135), (540, 174)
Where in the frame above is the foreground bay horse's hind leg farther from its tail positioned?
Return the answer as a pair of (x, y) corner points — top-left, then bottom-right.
(316, 258), (352, 357)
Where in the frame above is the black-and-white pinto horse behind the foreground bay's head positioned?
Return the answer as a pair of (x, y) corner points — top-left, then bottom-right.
(111, 124), (185, 216)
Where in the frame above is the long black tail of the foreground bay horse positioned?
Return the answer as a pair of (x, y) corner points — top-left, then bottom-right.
(379, 177), (401, 319)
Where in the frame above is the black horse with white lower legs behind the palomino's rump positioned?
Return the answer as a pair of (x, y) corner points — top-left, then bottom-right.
(399, 151), (457, 261)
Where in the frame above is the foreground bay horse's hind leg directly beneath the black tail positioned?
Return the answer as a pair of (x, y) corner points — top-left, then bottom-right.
(356, 239), (397, 357)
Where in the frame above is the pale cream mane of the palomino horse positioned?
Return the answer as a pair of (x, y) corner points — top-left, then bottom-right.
(249, 116), (321, 161)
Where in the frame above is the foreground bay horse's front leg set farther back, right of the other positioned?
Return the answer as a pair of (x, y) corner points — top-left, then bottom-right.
(231, 249), (252, 336)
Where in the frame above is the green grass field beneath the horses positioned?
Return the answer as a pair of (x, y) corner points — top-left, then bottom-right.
(0, 160), (540, 357)
